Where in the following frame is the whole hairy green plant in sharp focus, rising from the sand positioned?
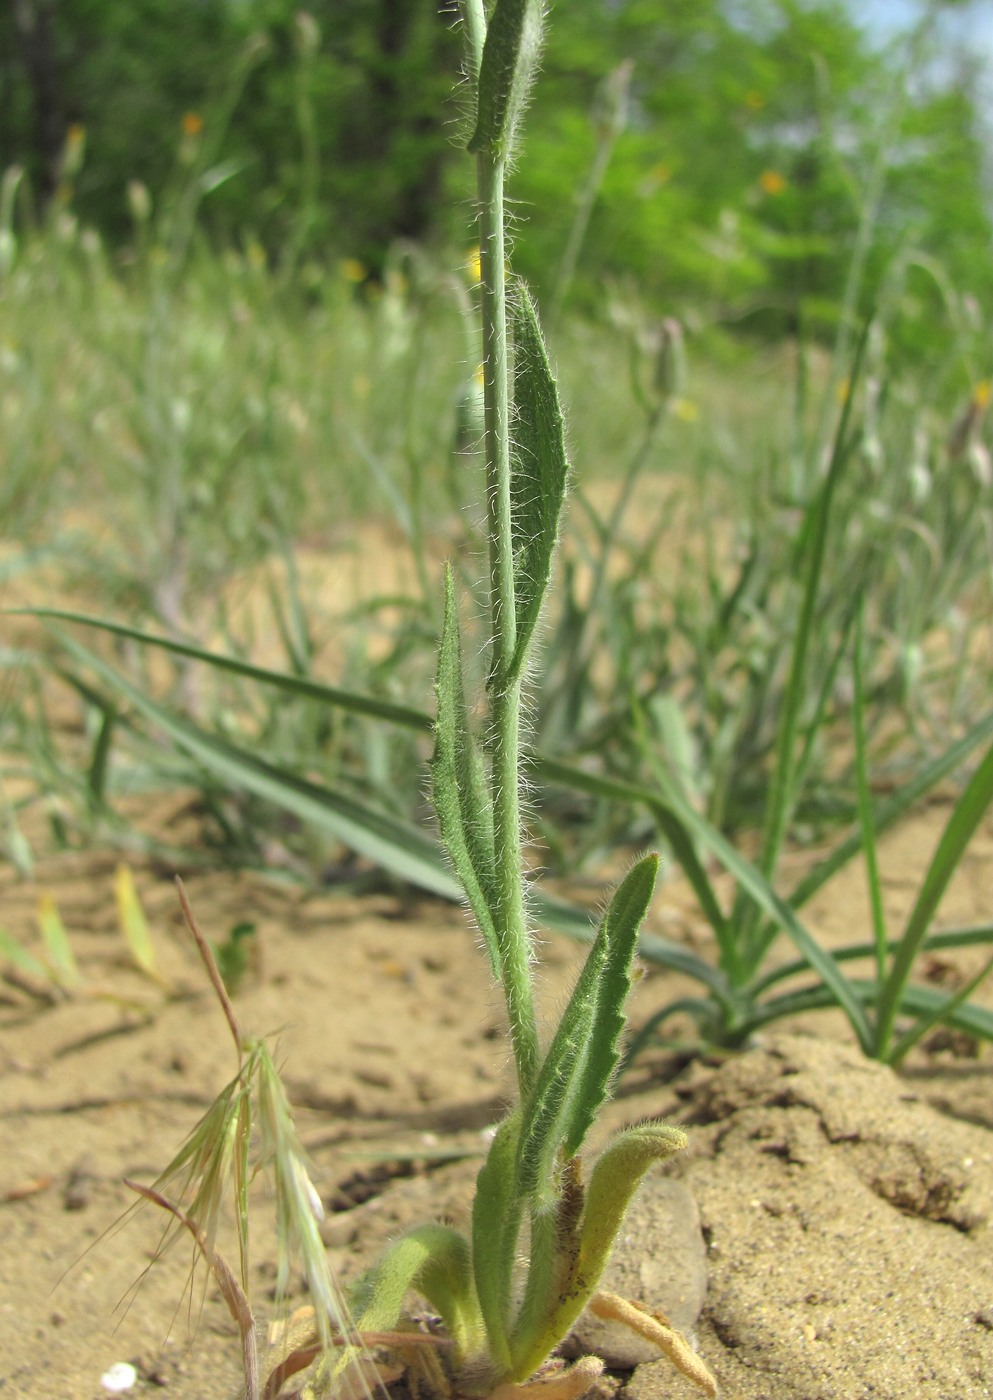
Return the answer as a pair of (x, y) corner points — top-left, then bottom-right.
(329, 0), (716, 1396)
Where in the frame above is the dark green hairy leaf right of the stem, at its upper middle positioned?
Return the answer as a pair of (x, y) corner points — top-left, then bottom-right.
(510, 283), (569, 675)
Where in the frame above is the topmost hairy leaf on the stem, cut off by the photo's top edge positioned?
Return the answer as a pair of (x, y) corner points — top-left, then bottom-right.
(469, 0), (543, 164)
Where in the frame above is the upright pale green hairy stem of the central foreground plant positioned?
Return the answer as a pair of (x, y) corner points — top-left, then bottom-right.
(478, 154), (538, 1096)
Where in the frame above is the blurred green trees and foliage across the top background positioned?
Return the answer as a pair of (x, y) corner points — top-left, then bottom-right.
(0, 0), (993, 347)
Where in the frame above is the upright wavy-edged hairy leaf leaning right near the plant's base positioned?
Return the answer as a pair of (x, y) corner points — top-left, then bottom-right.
(517, 855), (658, 1205)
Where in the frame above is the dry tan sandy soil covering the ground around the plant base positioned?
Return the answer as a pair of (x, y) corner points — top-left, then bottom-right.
(0, 806), (993, 1400)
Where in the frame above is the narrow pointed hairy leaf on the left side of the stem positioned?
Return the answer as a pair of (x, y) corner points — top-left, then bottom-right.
(431, 568), (500, 976)
